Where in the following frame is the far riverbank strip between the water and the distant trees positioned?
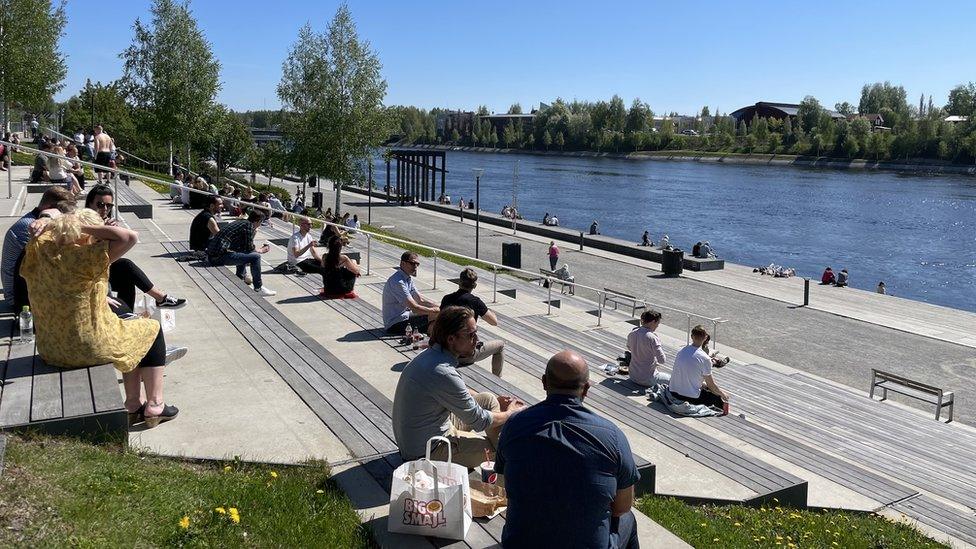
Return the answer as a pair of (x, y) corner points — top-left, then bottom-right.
(406, 145), (976, 175)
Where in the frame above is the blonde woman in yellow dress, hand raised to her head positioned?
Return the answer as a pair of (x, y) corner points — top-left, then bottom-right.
(21, 209), (179, 427)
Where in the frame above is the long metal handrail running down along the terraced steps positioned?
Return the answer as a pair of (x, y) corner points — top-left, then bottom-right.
(11, 141), (728, 340)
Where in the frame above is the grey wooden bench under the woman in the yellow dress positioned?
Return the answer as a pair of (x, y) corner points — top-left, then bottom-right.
(0, 319), (129, 440)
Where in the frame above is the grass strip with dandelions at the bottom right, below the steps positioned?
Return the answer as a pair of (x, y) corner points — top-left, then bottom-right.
(637, 496), (947, 549)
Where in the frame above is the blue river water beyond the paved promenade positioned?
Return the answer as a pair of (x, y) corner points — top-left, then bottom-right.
(376, 152), (976, 311)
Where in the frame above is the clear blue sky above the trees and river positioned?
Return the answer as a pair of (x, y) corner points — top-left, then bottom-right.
(57, 0), (976, 113)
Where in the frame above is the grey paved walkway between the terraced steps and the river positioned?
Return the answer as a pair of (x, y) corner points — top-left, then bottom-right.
(284, 182), (976, 424)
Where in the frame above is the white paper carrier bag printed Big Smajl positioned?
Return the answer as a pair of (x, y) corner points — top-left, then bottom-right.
(388, 437), (471, 540)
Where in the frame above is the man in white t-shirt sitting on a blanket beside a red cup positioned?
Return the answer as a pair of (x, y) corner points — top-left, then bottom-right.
(670, 325), (729, 415)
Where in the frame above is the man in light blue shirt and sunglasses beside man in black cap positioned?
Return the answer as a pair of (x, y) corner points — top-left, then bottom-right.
(383, 252), (440, 335)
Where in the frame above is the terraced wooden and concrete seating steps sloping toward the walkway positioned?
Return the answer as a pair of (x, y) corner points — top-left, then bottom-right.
(0, 162), (976, 547)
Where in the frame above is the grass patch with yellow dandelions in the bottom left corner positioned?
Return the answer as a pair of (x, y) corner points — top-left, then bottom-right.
(0, 437), (374, 547)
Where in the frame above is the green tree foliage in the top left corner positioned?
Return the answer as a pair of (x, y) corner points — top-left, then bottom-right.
(0, 0), (68, 124)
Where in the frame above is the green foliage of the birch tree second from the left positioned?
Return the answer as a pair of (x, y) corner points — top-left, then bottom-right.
(119, 0), (220, 156)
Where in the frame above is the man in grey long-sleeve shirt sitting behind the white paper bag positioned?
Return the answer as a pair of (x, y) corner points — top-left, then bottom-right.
(393, 307), (523, 467)
